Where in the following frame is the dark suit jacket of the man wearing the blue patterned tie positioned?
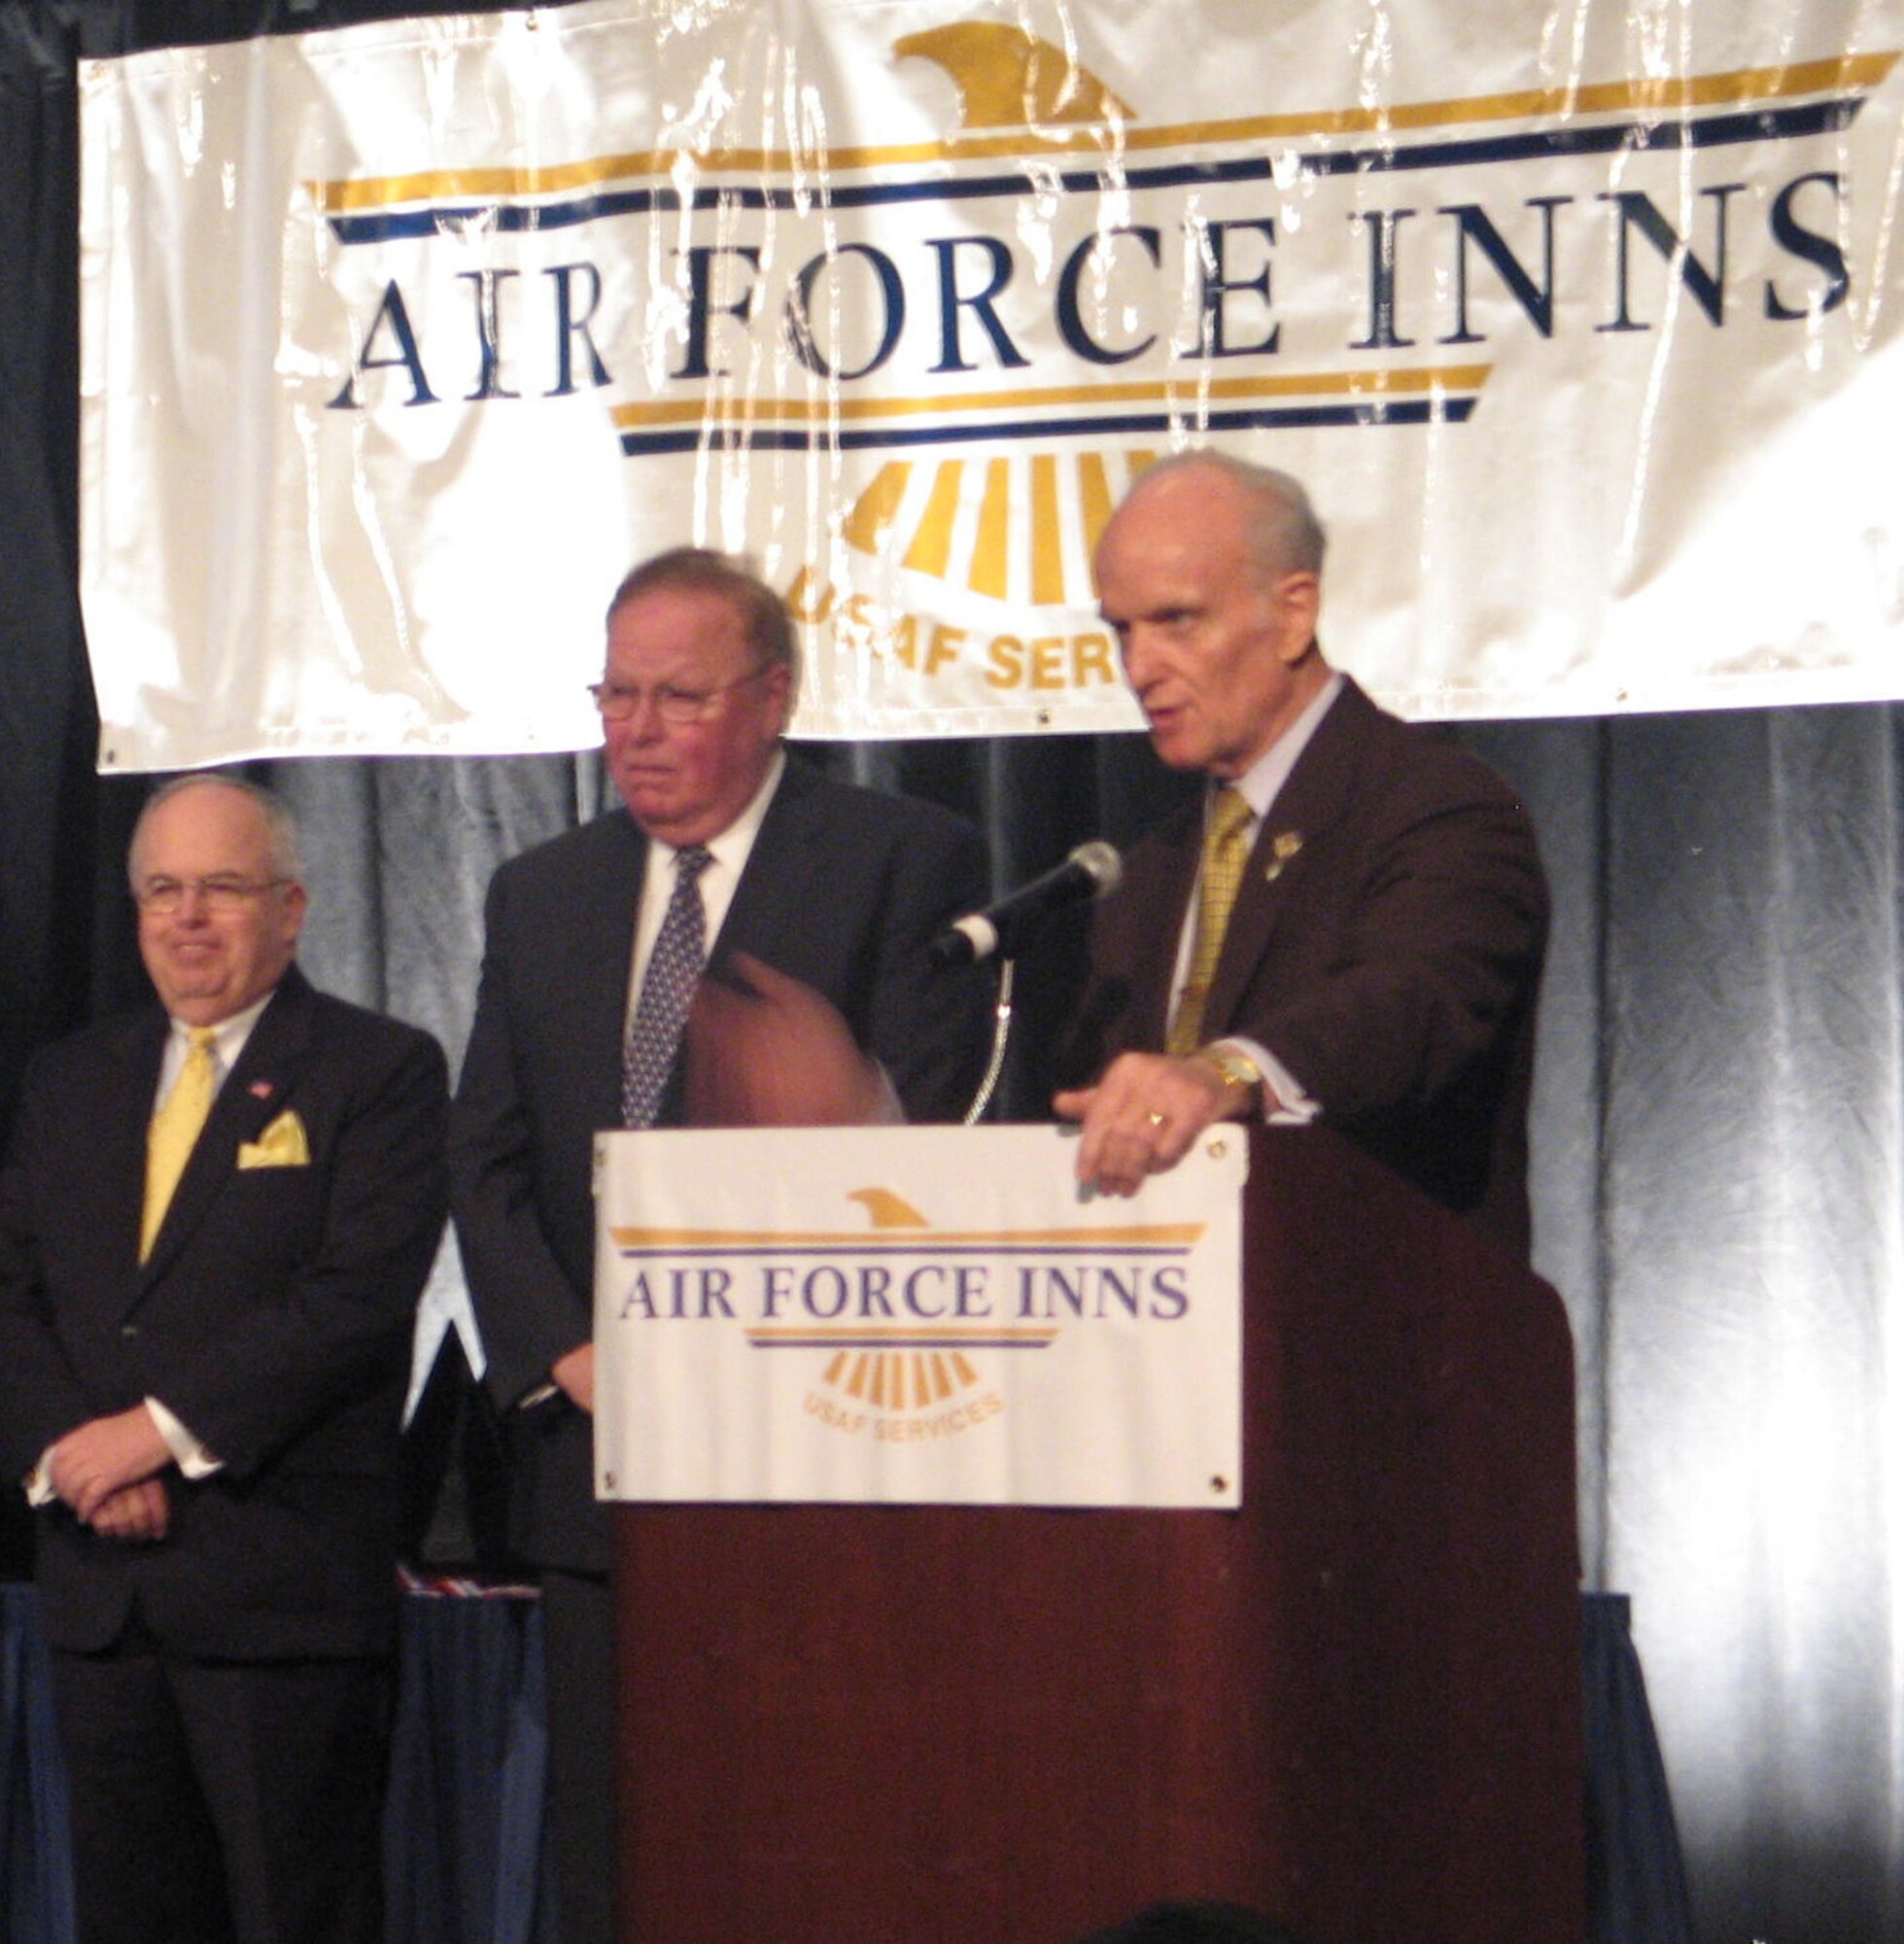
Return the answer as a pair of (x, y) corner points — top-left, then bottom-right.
(451, 760), (988, 1571)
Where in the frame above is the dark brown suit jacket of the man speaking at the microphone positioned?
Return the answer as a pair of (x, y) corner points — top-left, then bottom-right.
(1062, 682), (1546, 1256)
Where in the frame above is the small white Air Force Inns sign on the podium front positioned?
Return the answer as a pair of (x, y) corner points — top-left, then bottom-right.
(595, 1128), (1249, 1509)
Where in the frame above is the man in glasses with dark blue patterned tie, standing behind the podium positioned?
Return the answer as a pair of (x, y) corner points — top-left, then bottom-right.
(451, 548), (987, 1944)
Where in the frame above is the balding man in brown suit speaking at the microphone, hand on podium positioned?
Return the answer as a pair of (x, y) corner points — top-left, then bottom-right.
(1056, 451), (1546, 1256)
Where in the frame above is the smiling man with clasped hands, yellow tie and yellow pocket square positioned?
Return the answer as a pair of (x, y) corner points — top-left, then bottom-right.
(0, 776), (447, 1944)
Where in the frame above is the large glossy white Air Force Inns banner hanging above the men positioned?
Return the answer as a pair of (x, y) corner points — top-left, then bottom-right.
(82, 0), (1904, 768)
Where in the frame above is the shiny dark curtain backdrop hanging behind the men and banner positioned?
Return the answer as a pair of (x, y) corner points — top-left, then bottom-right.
(0, 0), (1904, 1944)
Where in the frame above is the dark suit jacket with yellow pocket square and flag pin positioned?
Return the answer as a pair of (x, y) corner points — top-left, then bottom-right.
(0, 968), (447, 1660)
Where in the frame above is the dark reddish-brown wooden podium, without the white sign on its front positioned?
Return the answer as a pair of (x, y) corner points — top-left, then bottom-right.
(614, 1128), (1585, 1944)
